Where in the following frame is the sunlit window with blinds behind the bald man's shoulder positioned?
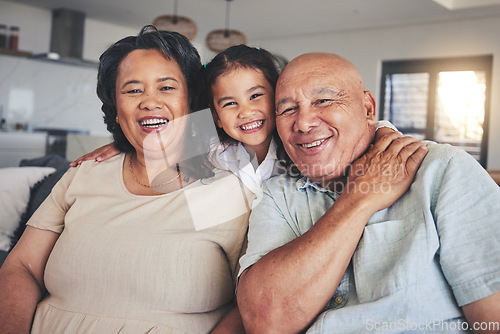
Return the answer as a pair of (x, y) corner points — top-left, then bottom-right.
(380, 56), (493, 167)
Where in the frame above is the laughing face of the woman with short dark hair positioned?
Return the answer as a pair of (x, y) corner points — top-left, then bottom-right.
(116, 49), (189, 160)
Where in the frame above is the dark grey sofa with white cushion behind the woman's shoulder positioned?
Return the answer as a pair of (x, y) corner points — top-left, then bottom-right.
(0, 155), (70, 266)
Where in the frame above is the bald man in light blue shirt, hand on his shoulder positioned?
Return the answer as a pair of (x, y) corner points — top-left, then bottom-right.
(237, 53), (500, 334)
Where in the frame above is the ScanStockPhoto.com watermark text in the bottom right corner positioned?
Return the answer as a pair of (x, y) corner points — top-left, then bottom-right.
(365, 319), (500, 333)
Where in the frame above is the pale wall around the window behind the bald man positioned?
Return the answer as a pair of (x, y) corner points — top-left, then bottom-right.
(251, 16), (500, 169)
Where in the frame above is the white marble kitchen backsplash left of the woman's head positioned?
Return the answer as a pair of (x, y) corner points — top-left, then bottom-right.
(0, 55), (107, 134)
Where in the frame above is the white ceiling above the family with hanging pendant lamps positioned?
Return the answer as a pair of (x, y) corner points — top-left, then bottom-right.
(7, 0), (500, 41)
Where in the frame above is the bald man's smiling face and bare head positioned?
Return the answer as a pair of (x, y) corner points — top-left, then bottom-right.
(276, 53), (375, 185)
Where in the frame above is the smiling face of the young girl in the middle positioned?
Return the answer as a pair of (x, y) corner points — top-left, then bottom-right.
(212, 67), (276, 152)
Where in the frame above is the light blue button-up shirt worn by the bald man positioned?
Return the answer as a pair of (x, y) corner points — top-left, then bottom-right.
(240, 142), (500, 333)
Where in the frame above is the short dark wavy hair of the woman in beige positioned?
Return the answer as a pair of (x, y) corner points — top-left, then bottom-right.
(97, 25), (201, 152)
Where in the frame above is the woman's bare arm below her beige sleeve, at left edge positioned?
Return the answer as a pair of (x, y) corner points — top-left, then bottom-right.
(0, 226), (59, 334)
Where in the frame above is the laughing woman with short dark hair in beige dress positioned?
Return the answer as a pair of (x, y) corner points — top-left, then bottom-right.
(0, 27), (251, 333)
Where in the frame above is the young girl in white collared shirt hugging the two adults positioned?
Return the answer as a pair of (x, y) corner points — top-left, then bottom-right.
(71, 45), (396, 198)
